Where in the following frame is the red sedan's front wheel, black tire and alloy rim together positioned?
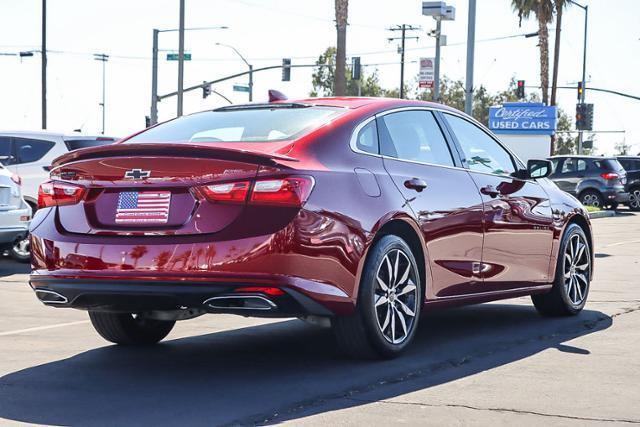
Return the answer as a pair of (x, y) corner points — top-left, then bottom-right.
(531, 223), (592, 316)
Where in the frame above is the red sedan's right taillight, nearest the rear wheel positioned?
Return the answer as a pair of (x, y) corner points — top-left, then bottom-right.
(199, 176), (314, 207)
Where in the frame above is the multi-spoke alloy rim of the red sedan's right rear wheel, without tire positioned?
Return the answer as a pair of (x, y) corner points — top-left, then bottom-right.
(374, 249), (418, 344)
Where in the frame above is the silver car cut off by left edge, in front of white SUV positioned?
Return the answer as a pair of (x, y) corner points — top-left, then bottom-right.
(0, 164), (31, 262)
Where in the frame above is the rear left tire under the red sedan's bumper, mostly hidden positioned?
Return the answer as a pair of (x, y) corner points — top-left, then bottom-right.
(89, 311), (176, 345)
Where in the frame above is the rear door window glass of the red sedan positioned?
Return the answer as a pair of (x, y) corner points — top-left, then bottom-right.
(379, 110), (454, 166)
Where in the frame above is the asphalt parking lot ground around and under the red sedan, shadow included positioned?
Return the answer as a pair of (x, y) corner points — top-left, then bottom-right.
(0, 212), (640, 426)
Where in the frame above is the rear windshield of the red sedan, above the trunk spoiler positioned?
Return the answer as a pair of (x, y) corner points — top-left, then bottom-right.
(126, 106), (344, 143)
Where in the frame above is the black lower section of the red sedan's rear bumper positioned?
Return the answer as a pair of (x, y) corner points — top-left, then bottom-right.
(30, 276), (334, 317)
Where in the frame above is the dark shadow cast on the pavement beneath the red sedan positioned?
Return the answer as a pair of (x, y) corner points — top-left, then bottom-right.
(0, 304), (612, 425)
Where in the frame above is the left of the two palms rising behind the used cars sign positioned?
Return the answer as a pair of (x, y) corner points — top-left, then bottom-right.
(511, 0), (553, 104)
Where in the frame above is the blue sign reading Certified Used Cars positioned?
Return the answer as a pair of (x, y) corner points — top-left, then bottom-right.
(489, 102), (558, 135)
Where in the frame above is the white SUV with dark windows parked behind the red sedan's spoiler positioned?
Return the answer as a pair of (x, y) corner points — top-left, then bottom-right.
(0, 131), (116, 210)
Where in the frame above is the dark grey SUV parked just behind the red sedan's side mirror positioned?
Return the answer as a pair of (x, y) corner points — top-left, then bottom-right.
(549, 156), (629, 209)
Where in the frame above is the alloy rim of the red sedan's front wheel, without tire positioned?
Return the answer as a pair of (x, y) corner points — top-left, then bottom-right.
(564, 234), (591, 306)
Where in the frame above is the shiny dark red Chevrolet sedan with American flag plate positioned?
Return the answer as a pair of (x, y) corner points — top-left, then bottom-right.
(30, 98), (593, 357)
